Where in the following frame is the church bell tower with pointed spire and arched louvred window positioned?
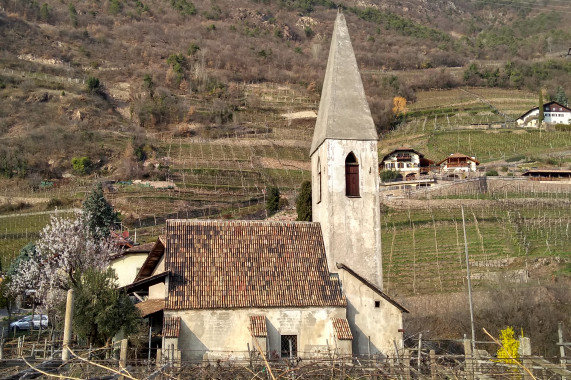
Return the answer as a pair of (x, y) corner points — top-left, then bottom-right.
(310, 13), (383, 289)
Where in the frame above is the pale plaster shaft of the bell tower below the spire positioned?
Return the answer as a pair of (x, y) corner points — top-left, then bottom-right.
(311, 139), (383, 287)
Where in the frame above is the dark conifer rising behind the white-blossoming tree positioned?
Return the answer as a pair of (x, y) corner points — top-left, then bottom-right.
(83, 183), (119, 237)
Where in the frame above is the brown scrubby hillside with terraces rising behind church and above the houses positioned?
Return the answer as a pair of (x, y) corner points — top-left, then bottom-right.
(0, 0), (571, 267)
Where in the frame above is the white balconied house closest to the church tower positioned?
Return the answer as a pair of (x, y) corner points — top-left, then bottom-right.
(379, 148), (434, 180)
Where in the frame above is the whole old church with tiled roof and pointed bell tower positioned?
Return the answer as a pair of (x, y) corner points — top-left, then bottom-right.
(126, 13), (408, 362)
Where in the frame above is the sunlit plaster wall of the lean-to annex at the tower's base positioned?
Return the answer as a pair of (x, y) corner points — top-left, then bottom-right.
(339, 270), (403, 357)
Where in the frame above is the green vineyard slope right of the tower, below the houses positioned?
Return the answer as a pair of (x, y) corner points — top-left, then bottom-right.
(382, 202), (571, 296)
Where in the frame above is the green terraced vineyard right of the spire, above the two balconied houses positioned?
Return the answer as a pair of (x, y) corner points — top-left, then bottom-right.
(380, 88), (571, 163)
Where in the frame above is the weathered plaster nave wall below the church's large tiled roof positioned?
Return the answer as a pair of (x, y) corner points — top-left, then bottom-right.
(165, 307), (350, 361)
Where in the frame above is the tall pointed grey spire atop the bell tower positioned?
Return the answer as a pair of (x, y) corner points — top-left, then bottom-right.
(310, 12), (378, 155)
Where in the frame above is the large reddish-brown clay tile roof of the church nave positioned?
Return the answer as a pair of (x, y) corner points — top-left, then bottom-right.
(165, 220), (346, 310)
